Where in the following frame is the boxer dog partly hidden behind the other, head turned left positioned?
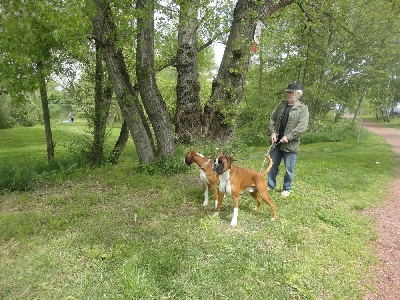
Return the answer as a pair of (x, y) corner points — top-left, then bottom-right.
(184, 150), (219, 207)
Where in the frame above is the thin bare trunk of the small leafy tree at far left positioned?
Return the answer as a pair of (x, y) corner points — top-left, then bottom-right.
(37, 62), (54, 162)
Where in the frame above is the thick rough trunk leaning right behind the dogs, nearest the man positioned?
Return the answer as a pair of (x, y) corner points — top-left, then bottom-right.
(204, 0), (294, 141)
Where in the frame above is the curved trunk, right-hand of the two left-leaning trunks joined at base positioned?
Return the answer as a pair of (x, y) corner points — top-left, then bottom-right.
(136, 0), (175, 156)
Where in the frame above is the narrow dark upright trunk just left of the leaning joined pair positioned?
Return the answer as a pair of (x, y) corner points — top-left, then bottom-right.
(92, 42), (112, 167)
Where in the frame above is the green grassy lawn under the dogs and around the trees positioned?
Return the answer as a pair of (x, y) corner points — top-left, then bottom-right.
(0, 118), (399, 300)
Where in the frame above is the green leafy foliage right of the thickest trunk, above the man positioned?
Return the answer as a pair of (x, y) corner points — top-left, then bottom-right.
(252, 0), (400, 118)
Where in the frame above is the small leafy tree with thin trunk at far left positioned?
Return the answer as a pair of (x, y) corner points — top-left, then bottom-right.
(0, 0), (86, 161)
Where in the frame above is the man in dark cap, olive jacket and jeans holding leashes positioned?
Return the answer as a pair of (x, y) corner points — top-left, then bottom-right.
(268, 82), (309, 198)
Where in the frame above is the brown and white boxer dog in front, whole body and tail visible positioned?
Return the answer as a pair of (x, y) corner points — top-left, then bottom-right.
(213, 154), (277, 226)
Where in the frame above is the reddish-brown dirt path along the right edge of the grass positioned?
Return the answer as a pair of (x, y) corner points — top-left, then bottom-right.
(361, 122), (400, 300)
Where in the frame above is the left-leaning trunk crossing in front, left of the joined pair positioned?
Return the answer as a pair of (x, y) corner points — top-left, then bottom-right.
(93, 0), (155, 163)
